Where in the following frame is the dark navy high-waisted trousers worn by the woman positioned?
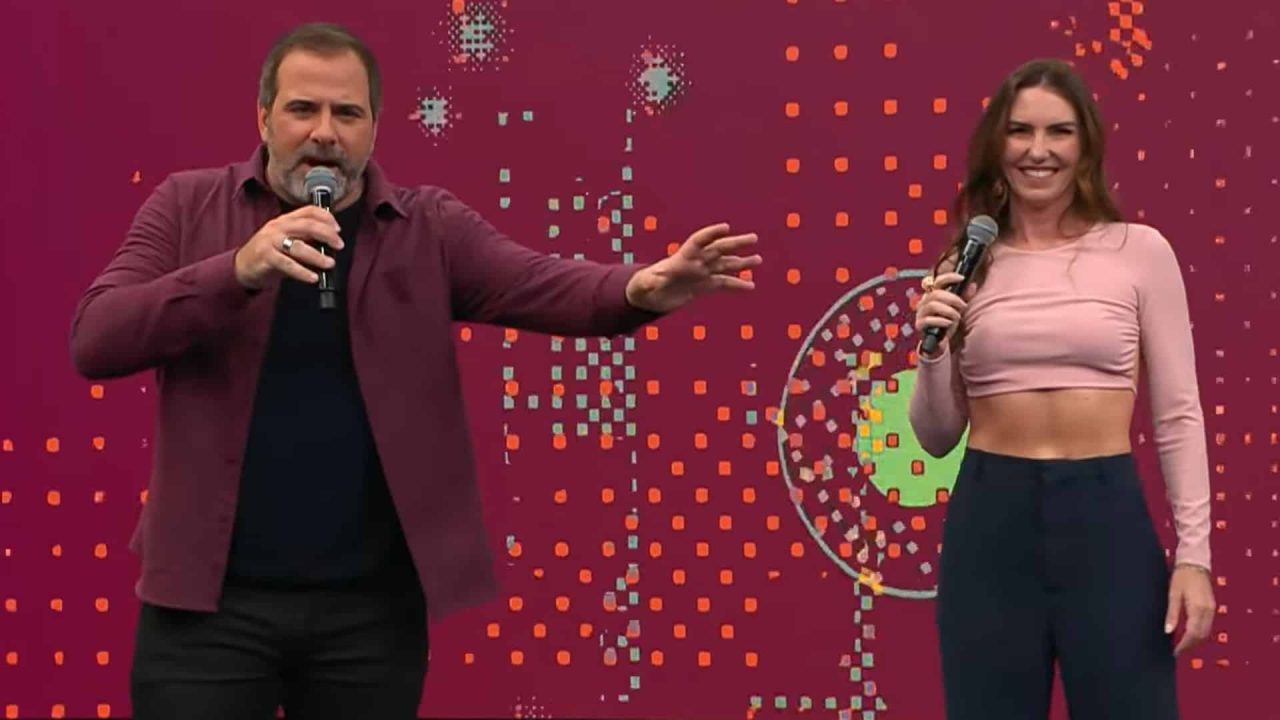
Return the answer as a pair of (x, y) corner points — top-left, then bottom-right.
(937, 448), (1178, 720)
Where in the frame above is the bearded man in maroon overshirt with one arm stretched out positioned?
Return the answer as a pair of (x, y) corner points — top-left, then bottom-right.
(70, 19), (760, 720)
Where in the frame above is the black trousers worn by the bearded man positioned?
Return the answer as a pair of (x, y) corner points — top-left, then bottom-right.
(131, 579), (428, 720)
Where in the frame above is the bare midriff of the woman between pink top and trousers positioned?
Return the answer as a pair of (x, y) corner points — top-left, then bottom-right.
(969, 388), (1134, 460)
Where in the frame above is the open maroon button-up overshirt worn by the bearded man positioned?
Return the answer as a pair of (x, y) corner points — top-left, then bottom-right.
(70, 147), (655, 618)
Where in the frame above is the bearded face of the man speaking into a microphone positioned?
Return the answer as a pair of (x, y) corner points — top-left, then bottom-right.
(257, 50), (378, 208)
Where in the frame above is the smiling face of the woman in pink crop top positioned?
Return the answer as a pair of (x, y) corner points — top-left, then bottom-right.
(1004, 87), (1080, 210)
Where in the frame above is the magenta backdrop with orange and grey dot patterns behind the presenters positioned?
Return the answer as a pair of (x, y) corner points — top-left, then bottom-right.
(0, 0), (1280, 720)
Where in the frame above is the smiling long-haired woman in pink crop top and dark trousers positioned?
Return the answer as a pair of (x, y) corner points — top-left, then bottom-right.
(910, 60), (1215, 720)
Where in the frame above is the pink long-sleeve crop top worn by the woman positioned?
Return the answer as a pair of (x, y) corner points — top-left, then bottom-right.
(909, 223), (1210, 569)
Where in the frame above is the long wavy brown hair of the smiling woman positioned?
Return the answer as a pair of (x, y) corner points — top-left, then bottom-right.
(933, 59), (1120, 288)
